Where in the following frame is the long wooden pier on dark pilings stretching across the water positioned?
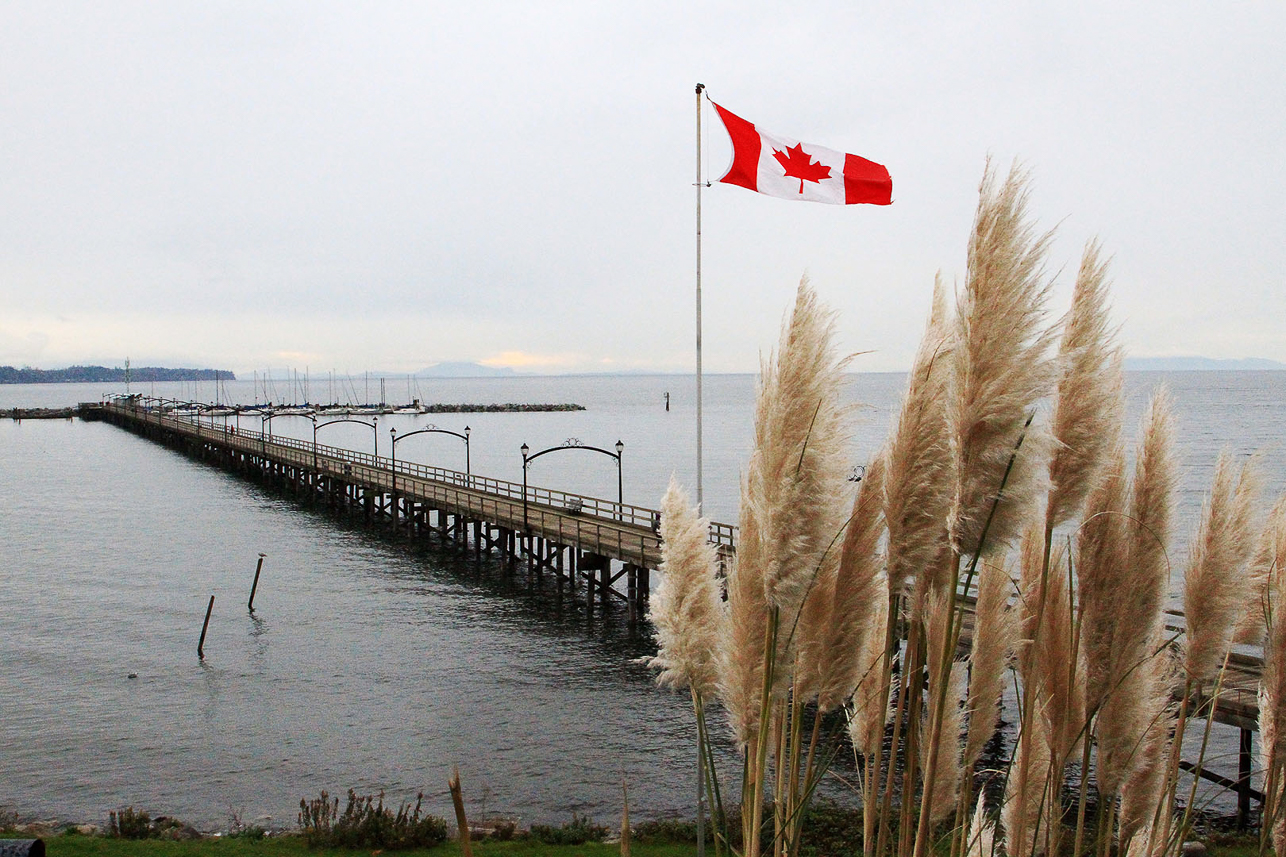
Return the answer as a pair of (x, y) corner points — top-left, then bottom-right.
(80, 398), (1263, 818)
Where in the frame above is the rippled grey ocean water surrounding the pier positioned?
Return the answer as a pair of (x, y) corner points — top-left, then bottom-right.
(0, 372), (1286, 827)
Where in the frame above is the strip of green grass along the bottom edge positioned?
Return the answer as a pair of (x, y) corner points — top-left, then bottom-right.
(8, 834), (712, 857)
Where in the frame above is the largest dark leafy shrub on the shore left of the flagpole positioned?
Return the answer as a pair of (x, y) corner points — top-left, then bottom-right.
(300, 789), (446, 851)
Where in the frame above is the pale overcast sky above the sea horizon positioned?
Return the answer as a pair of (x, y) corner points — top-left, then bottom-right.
(0, 0), (1286, 374)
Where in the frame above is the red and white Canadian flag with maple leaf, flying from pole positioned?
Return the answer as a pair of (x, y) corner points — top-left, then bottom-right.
(710, 102), (892, 206)
